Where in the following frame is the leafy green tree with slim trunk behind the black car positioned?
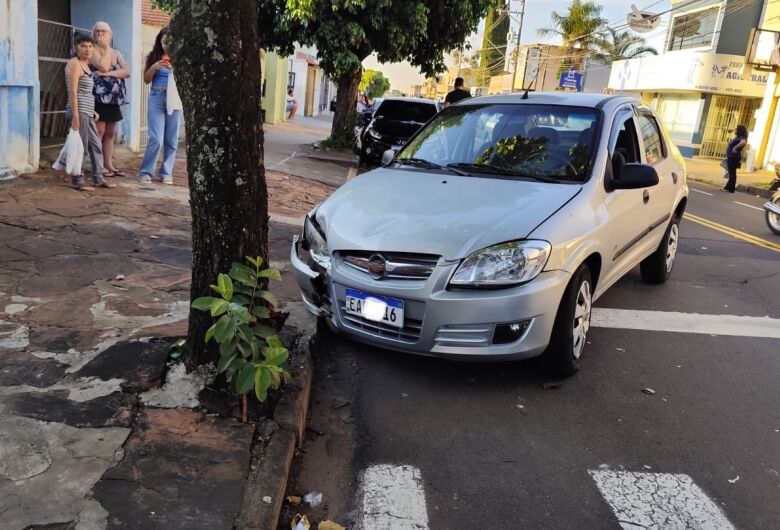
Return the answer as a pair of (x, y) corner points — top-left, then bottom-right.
(286, 0), (493, 146)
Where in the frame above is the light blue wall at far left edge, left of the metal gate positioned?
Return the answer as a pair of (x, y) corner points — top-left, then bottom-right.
(0, 2), (40, 179)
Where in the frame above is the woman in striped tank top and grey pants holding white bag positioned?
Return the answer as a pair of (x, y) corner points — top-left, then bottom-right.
(55, 33), (116, 191)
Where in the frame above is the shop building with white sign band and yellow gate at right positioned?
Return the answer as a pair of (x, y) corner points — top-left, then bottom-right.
(609, 0), (768, 158)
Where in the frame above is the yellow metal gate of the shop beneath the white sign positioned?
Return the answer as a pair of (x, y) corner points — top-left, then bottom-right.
(699, 96), (761, 158)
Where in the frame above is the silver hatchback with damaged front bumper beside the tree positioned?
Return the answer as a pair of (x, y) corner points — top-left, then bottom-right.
(291, 93), (688, 376)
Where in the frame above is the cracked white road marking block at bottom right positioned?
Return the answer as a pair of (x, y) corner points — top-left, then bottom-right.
(589, 469), (734, 530)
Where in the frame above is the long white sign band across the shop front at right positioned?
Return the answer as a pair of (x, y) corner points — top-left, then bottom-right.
(609, 51), (767, 97)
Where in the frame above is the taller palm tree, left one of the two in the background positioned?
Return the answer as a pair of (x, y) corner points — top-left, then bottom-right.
(538, 0), (607, 70)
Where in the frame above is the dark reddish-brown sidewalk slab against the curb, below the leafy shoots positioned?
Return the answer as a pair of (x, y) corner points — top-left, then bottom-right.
(94, 409), (253, 530)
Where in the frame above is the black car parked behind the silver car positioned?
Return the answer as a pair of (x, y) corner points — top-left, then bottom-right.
(356, 98), (438, 164)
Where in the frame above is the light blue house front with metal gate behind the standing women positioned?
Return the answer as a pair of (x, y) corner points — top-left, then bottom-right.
(0, 0), (142, 178)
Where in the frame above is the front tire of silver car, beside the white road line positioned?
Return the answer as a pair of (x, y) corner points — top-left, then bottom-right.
(542, 263), (593, 377)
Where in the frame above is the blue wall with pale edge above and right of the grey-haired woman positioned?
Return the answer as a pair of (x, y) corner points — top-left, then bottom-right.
(71, 0), (138, 142)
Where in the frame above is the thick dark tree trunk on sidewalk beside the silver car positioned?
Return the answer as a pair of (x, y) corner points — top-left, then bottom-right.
(171, 0), (268, 369)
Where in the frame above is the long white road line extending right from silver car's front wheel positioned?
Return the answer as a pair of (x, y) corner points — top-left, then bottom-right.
(591, 307), (780, 339)
